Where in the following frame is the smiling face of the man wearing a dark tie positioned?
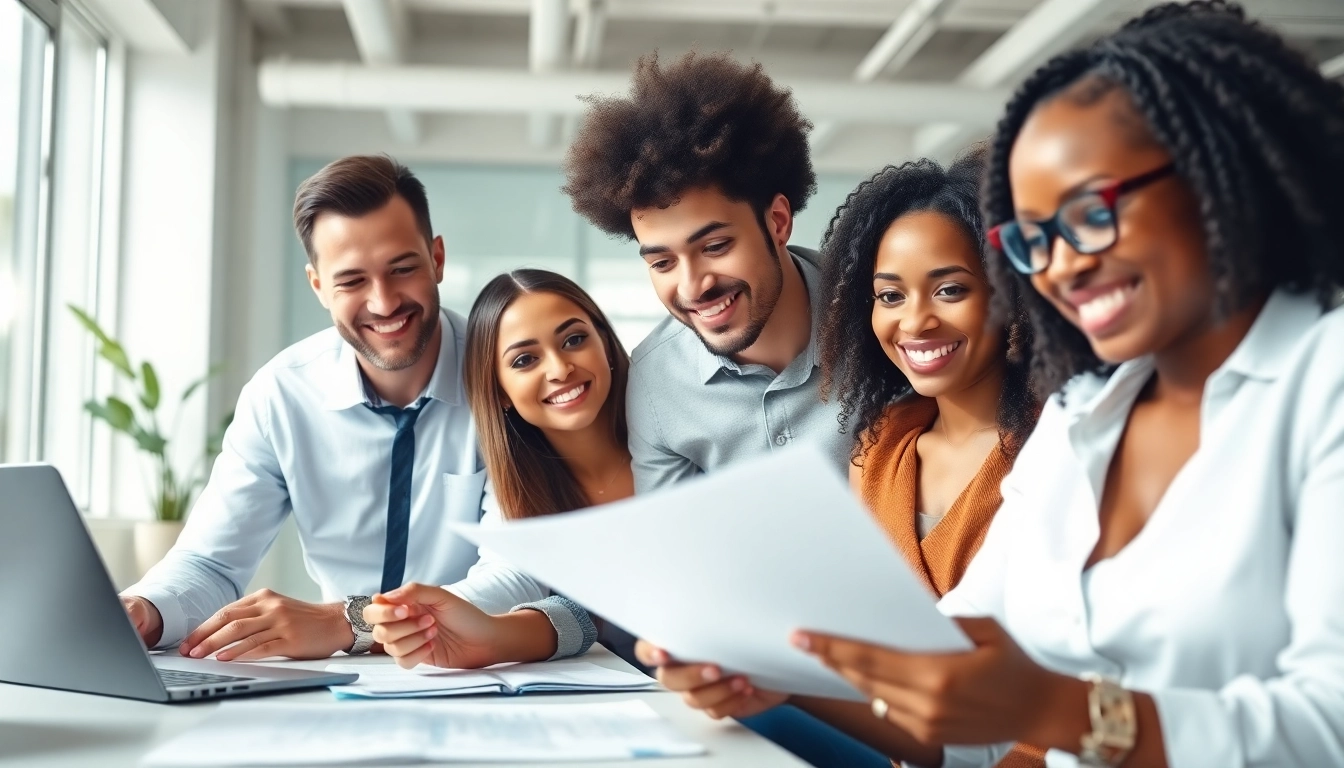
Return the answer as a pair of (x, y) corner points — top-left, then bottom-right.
(308, 195), (444, 371)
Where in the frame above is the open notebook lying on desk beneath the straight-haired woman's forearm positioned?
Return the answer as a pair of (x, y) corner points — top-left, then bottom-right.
(327, 659), (657, 698)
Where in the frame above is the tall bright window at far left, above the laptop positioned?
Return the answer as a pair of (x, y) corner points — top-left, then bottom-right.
(0, 0), (108, 508)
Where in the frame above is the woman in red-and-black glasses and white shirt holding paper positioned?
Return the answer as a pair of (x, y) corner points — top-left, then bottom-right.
(794, 3), (1344, 768)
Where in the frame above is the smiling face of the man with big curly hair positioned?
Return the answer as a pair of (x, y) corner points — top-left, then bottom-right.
(630, 187), (793, 356)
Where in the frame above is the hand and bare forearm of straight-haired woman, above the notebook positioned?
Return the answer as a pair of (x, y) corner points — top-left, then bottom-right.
(364, 584), (556, 670)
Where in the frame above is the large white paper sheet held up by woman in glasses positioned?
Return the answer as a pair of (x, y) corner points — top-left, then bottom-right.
(452, 444), (970, 701)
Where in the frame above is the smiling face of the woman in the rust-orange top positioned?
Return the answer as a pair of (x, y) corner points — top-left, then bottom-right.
(872, 211), (1004, 397)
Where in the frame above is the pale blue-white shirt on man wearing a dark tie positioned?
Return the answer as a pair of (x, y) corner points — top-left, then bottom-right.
(125, 309), (485, 647)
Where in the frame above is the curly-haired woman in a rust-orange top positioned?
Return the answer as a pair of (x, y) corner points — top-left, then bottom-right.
(821, 151), (1038, 596)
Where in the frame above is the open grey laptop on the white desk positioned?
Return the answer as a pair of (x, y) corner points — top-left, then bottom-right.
(0, 464), (359, 703)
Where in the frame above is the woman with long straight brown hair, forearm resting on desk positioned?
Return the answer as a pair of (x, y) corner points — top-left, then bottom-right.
(364, 269), (634, 668)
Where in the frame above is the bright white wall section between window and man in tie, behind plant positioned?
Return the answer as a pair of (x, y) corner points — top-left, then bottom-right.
(109, 0), (238, 518)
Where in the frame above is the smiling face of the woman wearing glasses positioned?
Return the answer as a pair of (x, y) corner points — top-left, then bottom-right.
(1008, 89), (1215, 363)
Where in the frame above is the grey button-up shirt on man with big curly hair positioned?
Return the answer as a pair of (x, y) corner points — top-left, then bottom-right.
(626, 246), (852, 494)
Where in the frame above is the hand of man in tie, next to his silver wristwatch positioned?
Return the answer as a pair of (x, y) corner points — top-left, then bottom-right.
(179, 589), (355, 662)
